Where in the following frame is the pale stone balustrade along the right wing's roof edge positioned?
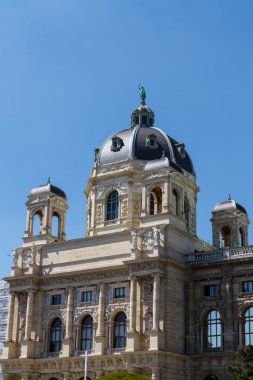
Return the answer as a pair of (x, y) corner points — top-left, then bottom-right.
(189, 246), (253, 265)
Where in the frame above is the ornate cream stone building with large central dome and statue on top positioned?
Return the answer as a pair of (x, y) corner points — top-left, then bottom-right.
(0, 93), (253, 380)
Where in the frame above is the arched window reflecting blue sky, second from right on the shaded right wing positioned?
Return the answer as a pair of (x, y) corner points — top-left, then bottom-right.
(206, 310), (222, 351)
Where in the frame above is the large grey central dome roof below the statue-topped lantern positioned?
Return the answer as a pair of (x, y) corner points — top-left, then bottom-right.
(96, 118), (194, 174)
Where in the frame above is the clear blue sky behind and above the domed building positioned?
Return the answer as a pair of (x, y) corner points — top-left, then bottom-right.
(0, 0), (253, 277)
